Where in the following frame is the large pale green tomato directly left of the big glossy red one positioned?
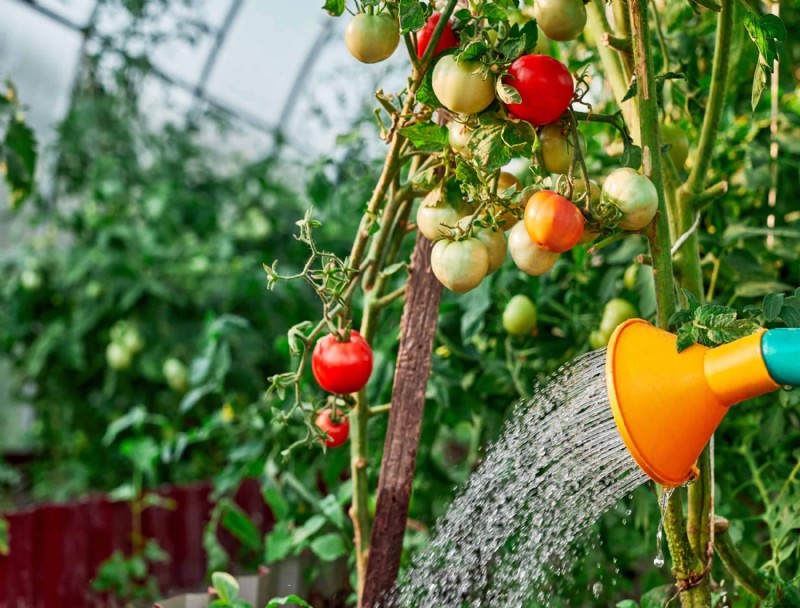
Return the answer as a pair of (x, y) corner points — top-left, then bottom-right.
(432, 55), (494, 114)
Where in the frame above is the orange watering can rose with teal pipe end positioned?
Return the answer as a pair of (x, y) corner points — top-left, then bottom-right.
(606, 319), (800, 487)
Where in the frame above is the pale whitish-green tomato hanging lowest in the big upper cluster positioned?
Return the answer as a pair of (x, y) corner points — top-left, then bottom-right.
(431, 238), (489, 293)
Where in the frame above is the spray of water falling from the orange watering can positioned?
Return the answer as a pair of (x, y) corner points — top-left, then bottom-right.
(385, 350), (647, 608)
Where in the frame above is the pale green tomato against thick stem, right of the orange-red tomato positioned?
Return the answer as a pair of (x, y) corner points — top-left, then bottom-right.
(601, 167), (658, 230)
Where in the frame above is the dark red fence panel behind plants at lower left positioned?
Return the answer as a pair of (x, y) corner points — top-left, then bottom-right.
(0, 480), (273, 608)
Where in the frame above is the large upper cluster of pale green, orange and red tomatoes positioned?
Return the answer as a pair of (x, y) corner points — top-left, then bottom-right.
(347, 0), (664, 293)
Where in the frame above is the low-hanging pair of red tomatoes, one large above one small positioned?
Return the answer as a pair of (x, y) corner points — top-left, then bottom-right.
(311, 330), (373, 448)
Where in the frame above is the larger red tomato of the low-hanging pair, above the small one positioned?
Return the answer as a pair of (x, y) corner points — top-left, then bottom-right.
(311, 331), (372, 395)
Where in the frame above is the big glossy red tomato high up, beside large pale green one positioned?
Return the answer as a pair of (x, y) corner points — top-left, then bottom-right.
(503, 55), (575, 126)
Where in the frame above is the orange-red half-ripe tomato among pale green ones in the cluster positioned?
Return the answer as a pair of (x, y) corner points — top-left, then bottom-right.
(524, 190), (585, 253)
